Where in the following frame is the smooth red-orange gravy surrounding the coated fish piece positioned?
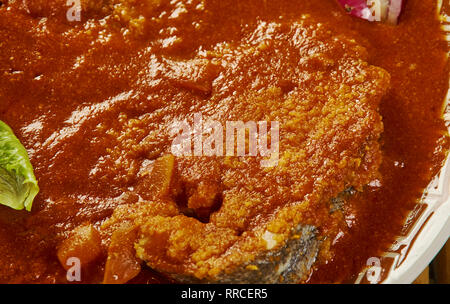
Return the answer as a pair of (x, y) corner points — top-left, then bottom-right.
(0, 0), (449, 283)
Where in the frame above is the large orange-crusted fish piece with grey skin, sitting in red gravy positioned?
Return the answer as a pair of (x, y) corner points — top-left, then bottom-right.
(105, 18), (390, 283)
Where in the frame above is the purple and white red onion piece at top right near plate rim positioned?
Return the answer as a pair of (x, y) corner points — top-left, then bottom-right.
(338, 0), (404, 24)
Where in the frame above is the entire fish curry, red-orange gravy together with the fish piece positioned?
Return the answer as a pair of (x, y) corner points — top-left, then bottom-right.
(0, 0), (449, 283)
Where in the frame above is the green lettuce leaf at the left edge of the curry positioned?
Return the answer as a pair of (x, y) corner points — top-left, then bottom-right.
(0, 120), (39, 211)
